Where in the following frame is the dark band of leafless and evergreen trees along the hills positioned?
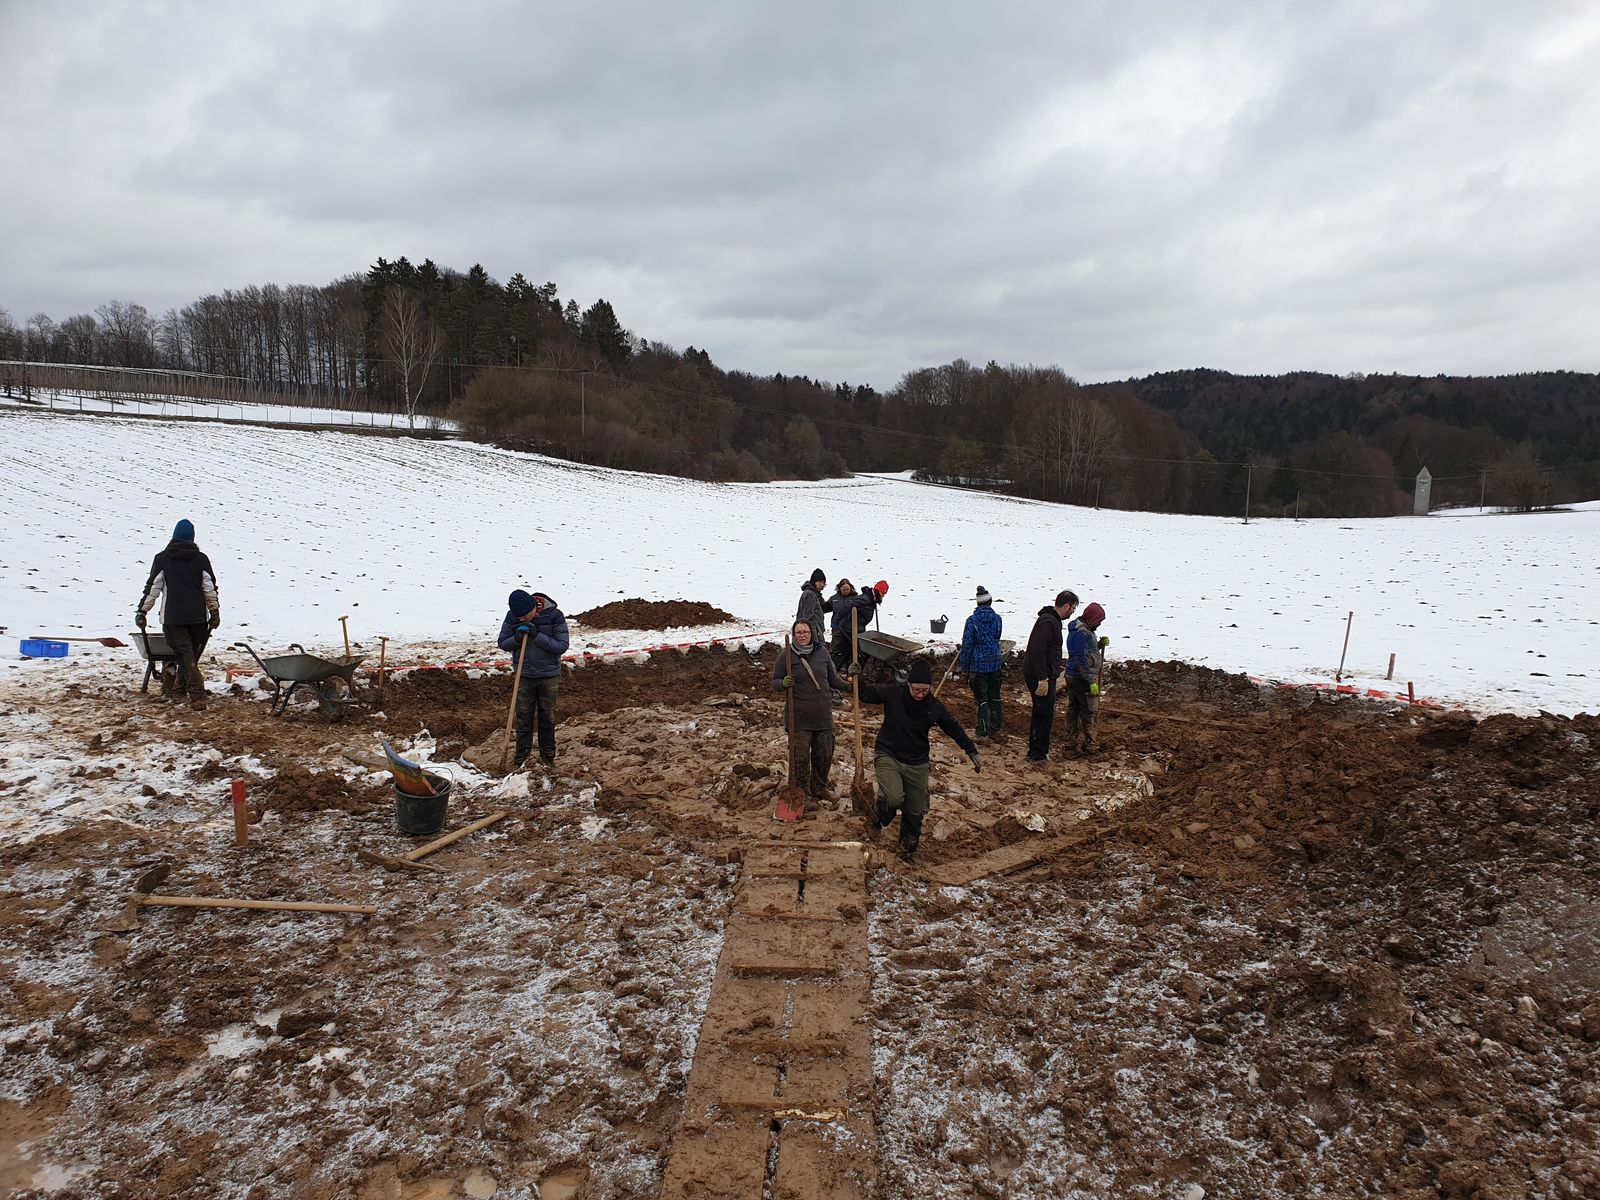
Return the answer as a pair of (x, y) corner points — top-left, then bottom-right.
(0, 258), (1600, 517)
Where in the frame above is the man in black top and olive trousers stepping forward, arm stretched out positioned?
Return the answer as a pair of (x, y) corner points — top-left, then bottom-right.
(850, 658), (984, 859)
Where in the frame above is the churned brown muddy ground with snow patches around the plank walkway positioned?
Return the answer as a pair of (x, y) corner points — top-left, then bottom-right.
(0, 633), (1600, 1200)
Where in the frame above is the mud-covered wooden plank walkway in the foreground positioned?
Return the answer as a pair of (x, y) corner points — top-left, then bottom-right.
(661, 842), (877, 1200)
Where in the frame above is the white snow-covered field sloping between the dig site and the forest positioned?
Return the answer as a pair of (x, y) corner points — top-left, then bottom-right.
(0, 408), (1600, 712)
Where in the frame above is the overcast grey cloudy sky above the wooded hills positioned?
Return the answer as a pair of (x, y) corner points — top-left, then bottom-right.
(0, 0), (1600, 387)
